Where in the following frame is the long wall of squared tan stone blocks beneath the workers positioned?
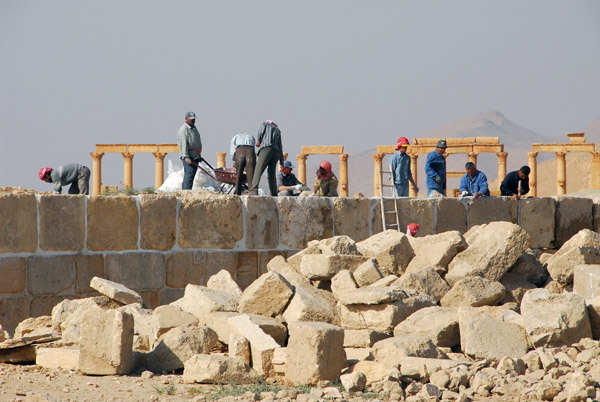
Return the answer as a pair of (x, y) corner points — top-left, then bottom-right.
(0, 194), (600, 331)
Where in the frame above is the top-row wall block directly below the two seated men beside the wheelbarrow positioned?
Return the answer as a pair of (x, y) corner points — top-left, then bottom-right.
(278, 197), (333, 249)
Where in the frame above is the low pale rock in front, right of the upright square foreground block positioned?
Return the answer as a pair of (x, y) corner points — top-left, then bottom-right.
(373, 336), (448, 368)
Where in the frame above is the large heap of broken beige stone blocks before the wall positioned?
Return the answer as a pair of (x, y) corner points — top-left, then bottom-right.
(0, 222), (600, 401)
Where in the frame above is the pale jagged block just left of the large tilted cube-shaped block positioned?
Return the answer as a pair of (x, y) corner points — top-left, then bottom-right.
(171, 285), (237, 320)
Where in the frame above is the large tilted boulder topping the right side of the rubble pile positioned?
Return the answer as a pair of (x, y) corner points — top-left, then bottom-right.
(444, 222), (529, 286)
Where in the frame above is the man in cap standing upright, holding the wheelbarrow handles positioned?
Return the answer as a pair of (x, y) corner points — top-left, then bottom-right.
(177, 112), (202, 190)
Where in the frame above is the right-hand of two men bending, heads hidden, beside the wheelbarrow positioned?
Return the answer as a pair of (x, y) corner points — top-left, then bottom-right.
(250, 120), (283, 197)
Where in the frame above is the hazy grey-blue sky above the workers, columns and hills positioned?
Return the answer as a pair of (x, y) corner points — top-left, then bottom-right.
(0, 0), (600, 191)
